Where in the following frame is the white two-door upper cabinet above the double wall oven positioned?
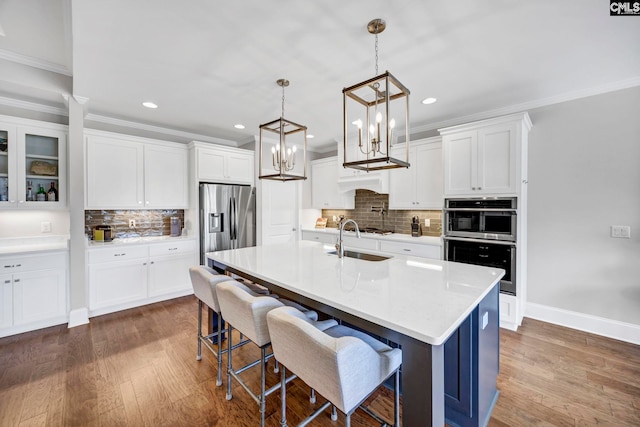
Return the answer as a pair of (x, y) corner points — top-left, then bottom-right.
(439, 113), (531, 196)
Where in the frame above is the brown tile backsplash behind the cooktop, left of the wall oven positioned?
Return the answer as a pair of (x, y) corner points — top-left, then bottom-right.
(322, 190), (442, 237)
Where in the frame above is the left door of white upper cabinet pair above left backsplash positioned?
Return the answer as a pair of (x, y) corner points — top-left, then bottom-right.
(86, 136), (144, 209)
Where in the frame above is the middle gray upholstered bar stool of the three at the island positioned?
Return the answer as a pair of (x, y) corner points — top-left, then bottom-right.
(216, 281), (324, 426)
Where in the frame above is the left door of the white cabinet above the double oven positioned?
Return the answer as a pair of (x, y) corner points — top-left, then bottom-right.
(442, 131), (478, 195)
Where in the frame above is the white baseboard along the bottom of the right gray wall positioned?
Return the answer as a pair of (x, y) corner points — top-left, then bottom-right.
(524, 302), (640, 344)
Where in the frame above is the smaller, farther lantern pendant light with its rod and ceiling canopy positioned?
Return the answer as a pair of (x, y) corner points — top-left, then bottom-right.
(258, 79), (307, 182)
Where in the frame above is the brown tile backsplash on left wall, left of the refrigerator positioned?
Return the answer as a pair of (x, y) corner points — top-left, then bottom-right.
(84, 209), (184, 237)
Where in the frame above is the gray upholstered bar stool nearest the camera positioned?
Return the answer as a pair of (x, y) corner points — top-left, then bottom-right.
(267, 307), (402, 427)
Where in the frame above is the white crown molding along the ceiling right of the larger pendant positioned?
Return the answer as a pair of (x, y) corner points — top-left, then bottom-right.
(411, 76), (640, 134)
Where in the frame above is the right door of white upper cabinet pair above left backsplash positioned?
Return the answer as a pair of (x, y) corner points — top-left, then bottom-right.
(144, 144), (189, 209)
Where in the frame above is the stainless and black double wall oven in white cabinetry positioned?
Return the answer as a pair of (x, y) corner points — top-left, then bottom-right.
(443, 197), (518, 295)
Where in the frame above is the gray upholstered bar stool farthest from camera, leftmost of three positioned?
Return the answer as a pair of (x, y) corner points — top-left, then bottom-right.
(189, 265), (249, 386)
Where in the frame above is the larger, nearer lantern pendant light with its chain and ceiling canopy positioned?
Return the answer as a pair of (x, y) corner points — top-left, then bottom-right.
(342, 19), (409, 171)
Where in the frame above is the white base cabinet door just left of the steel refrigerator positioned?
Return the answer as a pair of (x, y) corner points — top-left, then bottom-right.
(149, 254), (194, 297)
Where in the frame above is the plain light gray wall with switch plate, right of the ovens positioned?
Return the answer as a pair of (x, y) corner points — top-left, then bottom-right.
(527, 87), (640, 326)
